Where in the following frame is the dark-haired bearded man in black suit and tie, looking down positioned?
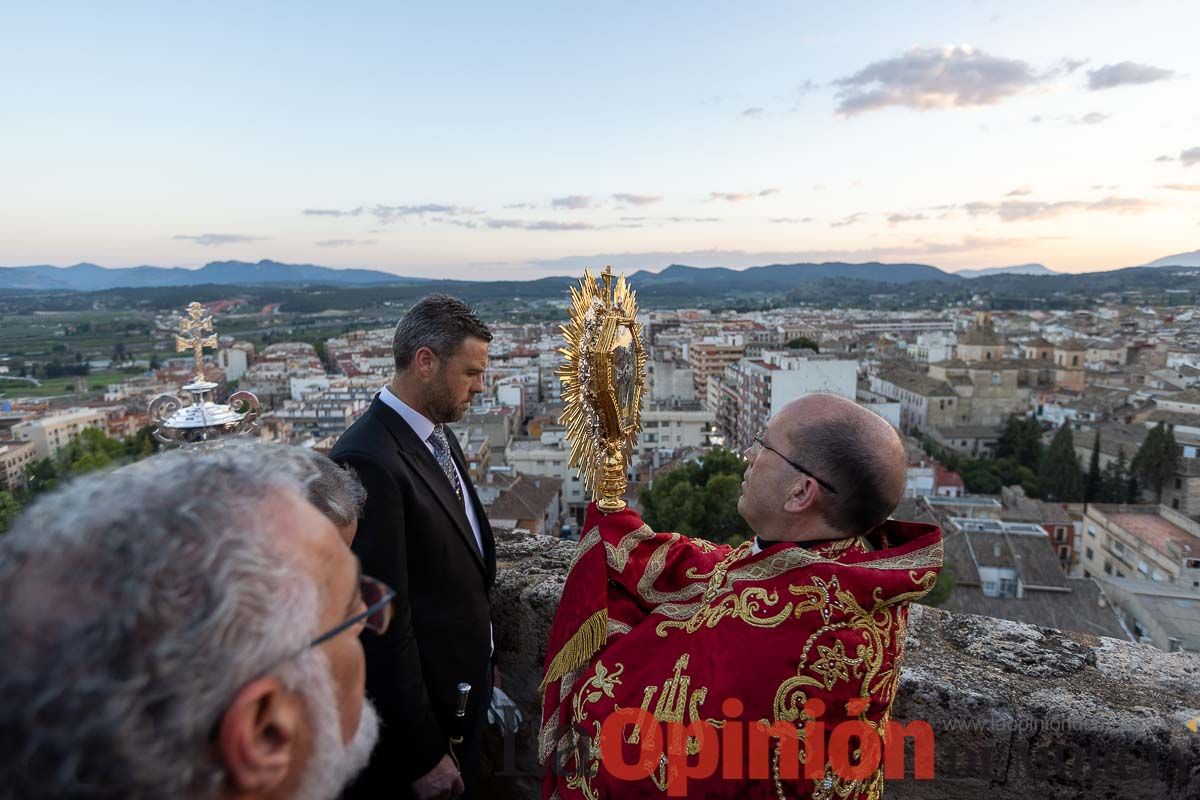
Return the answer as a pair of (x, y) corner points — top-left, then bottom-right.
(330, 295), (496, 800)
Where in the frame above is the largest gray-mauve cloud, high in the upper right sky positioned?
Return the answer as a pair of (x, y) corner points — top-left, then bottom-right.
(834, 46), (1045, 116)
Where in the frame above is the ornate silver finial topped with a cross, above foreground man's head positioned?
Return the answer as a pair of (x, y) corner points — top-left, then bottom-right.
(149, 302), (259, 445)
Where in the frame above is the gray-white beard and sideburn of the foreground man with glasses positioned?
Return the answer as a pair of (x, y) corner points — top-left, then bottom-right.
(286, 650), (379, 800)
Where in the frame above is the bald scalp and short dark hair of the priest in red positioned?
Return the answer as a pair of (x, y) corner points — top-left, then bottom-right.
(772, 395), (907, 535)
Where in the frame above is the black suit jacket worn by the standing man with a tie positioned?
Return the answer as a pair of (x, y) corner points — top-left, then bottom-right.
(330, 397), (496, 798)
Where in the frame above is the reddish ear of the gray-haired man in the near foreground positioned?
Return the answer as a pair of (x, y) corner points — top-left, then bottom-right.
(217, 678), (304, 794)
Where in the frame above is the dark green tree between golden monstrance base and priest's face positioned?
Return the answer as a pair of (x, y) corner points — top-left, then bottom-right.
(638, 447), (751, 545)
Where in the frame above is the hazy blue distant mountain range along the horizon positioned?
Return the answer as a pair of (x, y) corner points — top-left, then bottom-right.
(0, 251), (1200, 295)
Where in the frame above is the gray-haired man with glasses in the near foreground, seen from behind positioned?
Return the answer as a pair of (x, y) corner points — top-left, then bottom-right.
(0, 446), (389, 800)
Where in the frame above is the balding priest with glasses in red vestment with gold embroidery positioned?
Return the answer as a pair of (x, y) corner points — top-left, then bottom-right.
(539, 395), (942, 800)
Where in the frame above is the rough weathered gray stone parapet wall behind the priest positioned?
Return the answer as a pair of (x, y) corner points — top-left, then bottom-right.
(481, 530), (1200, 800)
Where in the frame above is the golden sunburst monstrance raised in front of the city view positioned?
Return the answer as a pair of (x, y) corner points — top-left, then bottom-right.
(558, 266), (646, 513)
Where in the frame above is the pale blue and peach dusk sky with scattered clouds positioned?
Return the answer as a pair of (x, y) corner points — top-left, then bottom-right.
(0, 0), (1200, 279)
